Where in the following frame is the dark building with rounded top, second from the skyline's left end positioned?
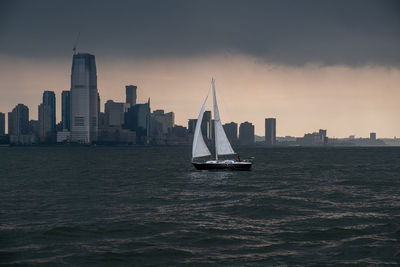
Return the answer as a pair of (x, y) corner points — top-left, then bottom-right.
(8, 104), (29, 136)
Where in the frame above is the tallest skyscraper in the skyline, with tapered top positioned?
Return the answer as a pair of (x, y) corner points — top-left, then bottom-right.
(70, 53), (99, 144)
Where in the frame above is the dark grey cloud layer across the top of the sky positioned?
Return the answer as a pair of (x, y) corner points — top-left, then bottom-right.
(0, 0), (400, 66)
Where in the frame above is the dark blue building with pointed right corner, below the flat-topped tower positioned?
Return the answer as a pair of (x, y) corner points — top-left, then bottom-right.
(124, 99), (150, 144)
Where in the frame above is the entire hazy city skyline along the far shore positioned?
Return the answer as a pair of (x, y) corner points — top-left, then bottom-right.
(0, 51), (400, 149)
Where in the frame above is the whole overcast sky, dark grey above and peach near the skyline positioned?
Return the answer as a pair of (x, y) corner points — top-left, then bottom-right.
(0, 0), (400, 137)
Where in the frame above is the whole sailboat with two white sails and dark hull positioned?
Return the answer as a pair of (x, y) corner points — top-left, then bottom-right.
(192, 78), (252, 170)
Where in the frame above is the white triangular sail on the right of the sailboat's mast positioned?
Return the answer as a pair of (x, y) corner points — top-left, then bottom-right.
(212, 78), (235, 159)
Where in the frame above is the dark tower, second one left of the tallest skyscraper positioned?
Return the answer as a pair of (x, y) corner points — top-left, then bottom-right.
(38, 91), (56, 143)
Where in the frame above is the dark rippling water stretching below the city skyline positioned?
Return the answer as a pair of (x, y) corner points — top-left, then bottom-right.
(0, 147), (400, 266)
